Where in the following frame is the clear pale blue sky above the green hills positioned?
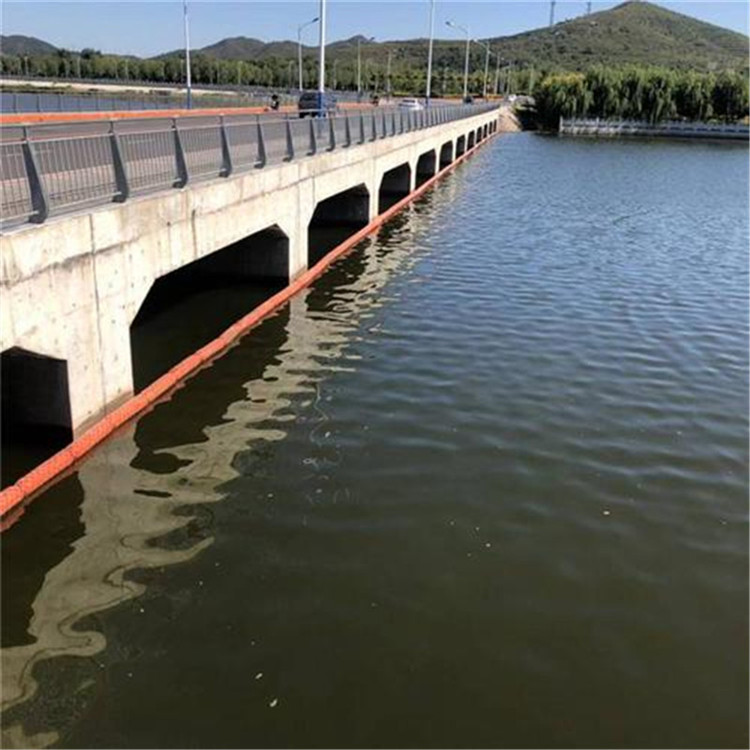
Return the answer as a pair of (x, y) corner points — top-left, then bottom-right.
(2, 0), (748, 56)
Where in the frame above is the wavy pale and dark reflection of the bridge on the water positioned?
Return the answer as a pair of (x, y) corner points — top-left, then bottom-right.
(2, 204), (428, 747)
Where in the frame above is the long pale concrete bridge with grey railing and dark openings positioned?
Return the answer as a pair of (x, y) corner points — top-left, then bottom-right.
(0, 101), (498, 484)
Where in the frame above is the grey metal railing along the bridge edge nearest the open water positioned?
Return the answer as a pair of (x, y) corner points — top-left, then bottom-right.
(0, 104), (497, 228)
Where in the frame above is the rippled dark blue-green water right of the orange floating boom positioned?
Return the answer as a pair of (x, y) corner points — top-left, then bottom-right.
(2, 135), (748, 747)
